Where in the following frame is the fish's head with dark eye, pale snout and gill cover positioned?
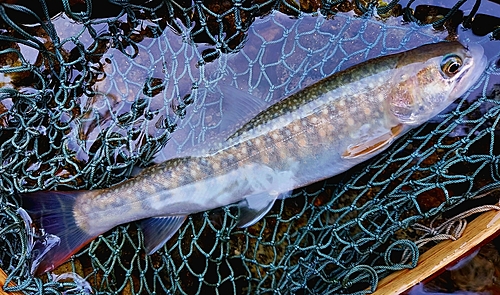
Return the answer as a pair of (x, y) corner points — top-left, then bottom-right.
(388, 42), (487, 126)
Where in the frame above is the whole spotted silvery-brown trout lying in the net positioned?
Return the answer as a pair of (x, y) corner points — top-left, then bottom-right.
(19, 42), (487, 274)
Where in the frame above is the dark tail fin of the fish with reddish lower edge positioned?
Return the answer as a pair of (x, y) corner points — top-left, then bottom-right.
(20, 191), (95, 275)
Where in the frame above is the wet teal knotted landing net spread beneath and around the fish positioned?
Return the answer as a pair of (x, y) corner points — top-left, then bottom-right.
(0, 0), (500, 294)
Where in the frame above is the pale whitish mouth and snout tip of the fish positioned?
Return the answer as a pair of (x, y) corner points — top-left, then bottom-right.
(450, 43), (488, 99)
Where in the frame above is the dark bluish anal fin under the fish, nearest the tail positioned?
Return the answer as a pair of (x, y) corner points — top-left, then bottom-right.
(140, 216), (186, 254)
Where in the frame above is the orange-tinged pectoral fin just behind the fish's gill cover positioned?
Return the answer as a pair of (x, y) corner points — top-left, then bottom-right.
(342, 124), (405, 159)
